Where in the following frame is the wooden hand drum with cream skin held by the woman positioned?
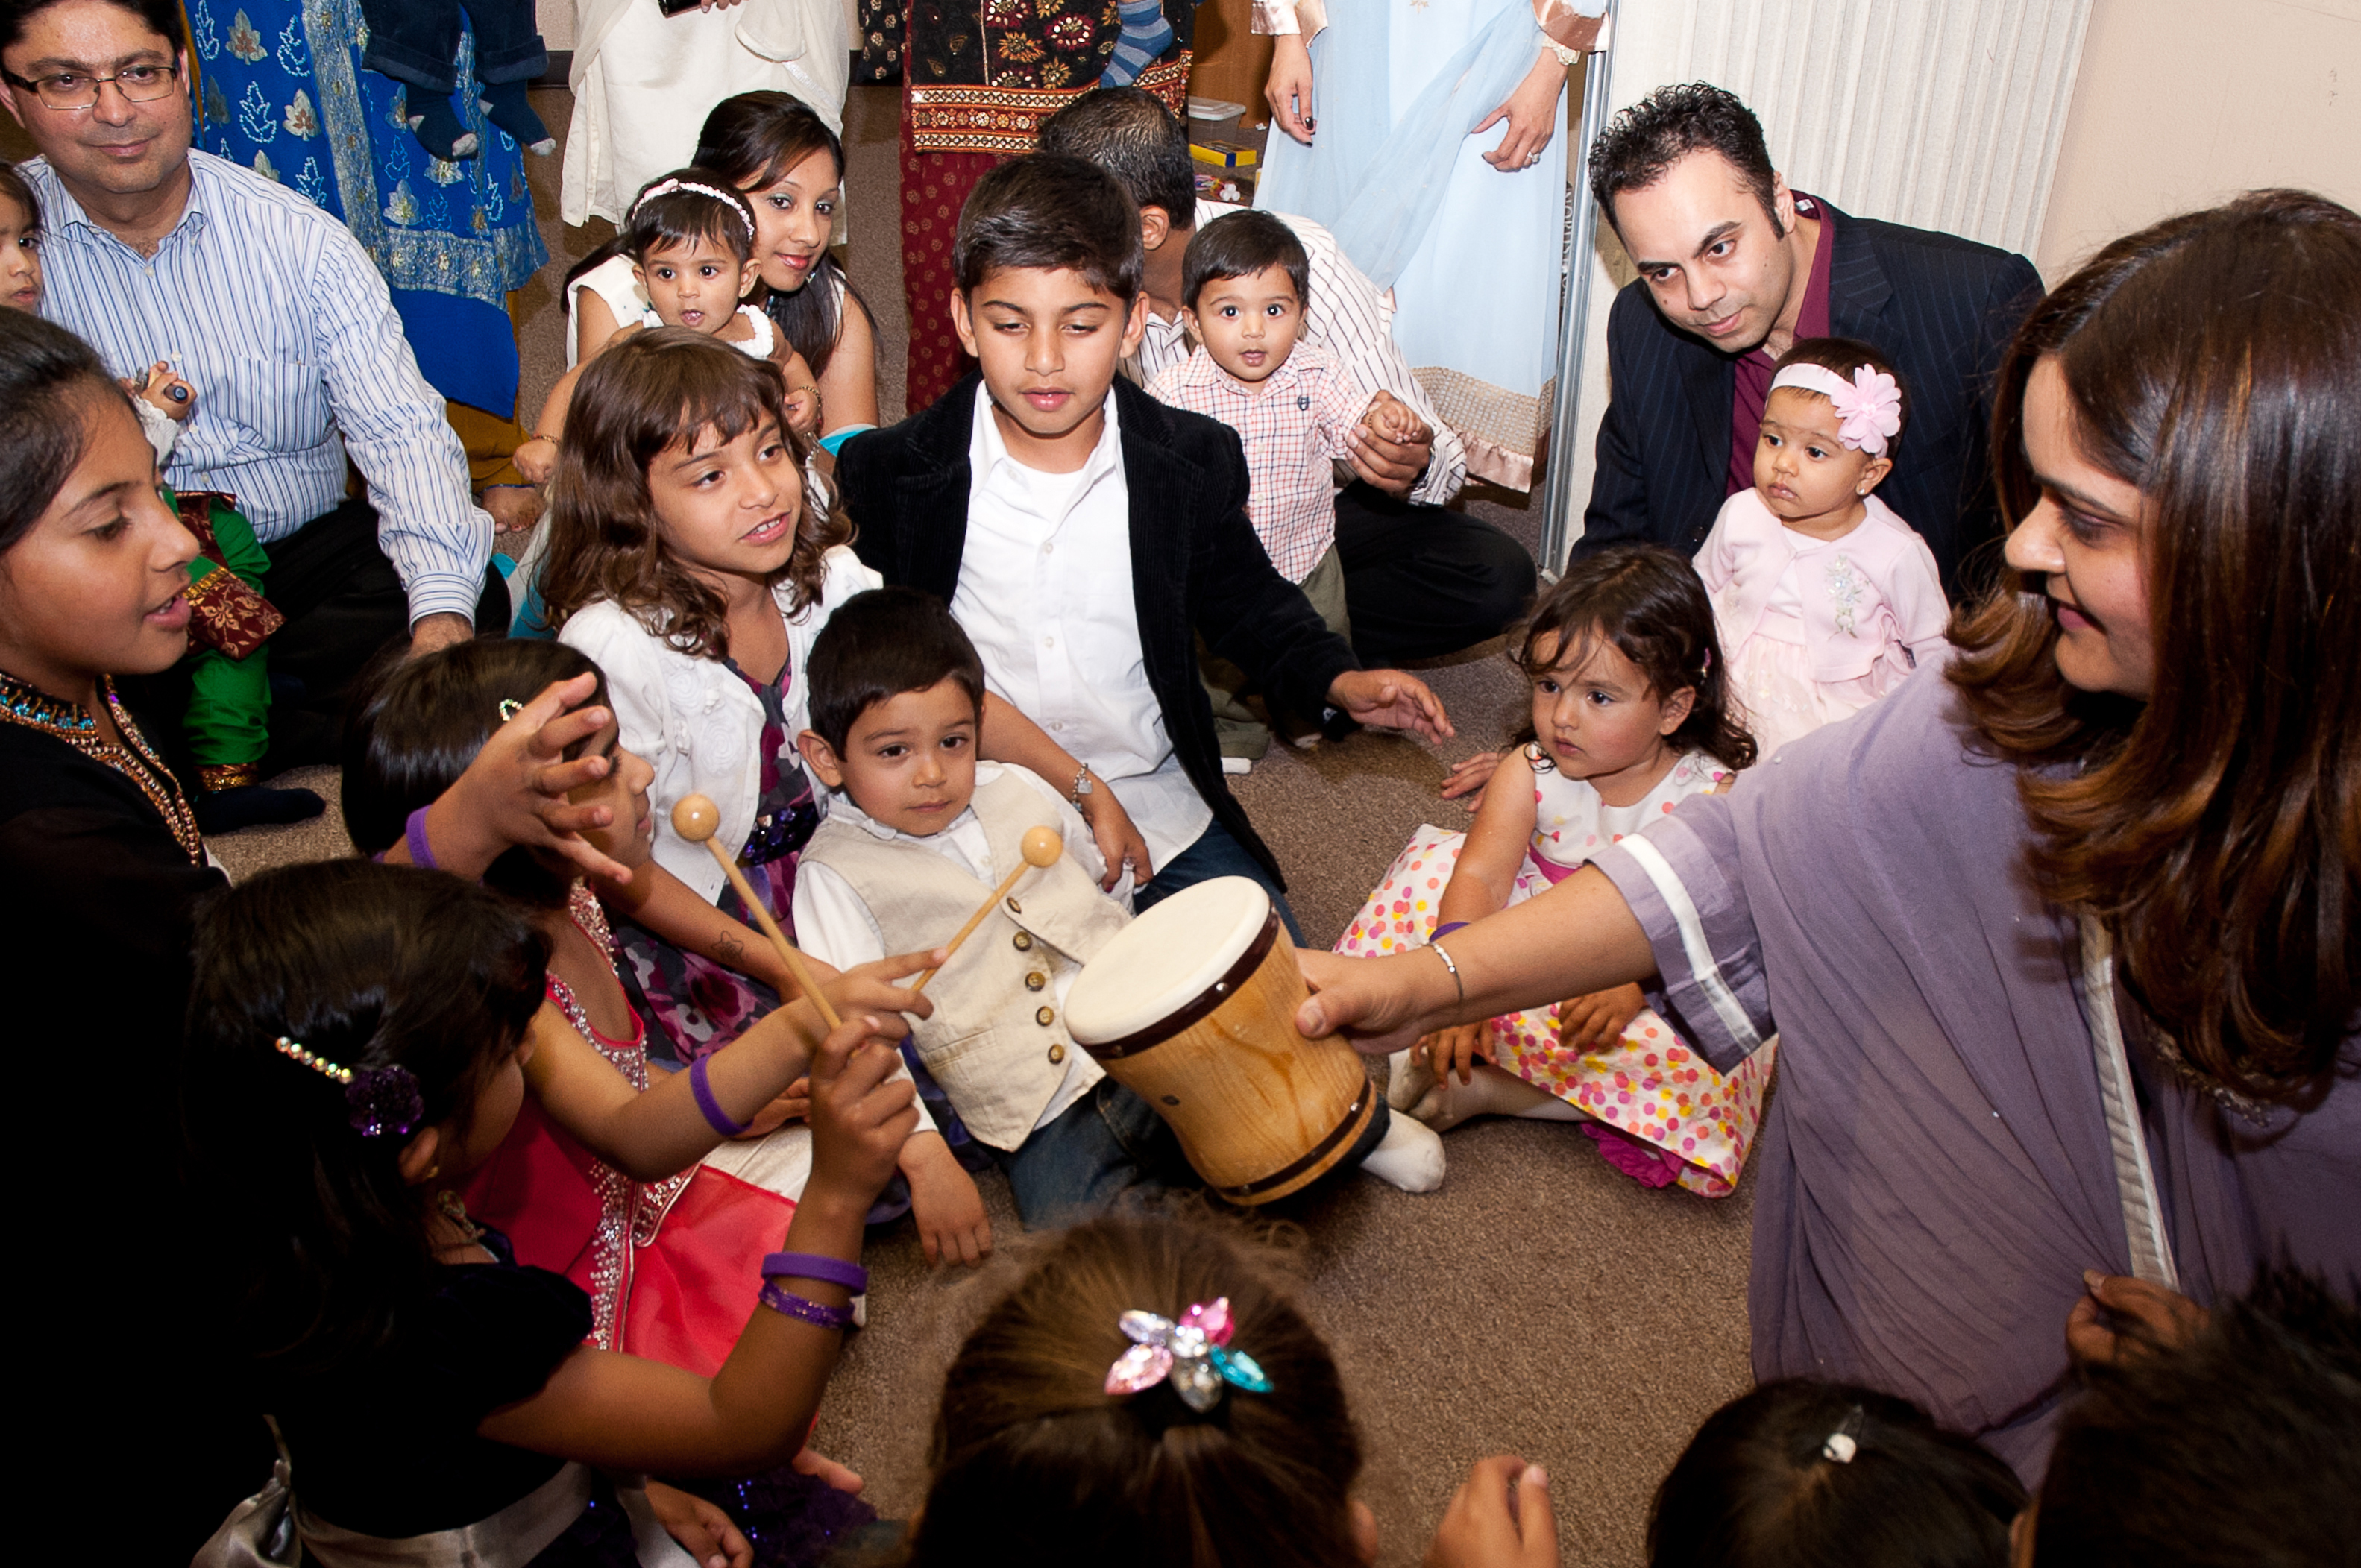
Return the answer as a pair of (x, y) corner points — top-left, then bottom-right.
(1065, 876), (1377, 1204)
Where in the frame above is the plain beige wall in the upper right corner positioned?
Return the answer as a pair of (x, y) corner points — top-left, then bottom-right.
(2033, 0), (2361, 283)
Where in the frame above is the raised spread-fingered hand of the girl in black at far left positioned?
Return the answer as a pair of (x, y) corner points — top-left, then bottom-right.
(415, 676), (630, 884)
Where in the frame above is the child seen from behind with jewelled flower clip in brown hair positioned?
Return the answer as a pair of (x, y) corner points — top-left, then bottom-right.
(897, 1216), (1559, 1568)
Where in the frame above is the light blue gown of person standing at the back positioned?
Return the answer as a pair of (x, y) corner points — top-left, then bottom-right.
(1256, 0), (1565, 489)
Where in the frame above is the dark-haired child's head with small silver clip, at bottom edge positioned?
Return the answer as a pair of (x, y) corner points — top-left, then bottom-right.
(1648, 1376), (2030, 1568)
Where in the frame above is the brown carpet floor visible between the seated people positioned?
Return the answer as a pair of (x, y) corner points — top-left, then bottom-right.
(198, 87), (1752, 1566)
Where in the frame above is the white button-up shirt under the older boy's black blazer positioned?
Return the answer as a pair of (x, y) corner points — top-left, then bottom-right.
(952, 385), (1213, 866)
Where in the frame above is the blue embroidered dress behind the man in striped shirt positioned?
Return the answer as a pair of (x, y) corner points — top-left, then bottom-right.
(189, 0), (548, 415)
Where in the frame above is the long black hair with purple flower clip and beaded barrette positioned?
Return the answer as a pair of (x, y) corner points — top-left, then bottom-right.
(180, 860), (550, 1367)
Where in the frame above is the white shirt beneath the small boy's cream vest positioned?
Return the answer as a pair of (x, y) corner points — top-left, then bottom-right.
(796, 763), (1131, 1131)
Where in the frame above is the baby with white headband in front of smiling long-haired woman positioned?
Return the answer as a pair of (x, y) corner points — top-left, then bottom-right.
(515, 168), (820, 484)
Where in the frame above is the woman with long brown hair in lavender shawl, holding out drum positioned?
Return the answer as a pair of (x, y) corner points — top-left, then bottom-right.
(1298, 192), (2361, 1479)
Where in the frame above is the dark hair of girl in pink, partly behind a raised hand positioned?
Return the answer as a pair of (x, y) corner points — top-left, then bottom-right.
(340, 637), (607, 909)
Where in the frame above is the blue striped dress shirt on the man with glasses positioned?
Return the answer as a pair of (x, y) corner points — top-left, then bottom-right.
(16, 149), (491, 621)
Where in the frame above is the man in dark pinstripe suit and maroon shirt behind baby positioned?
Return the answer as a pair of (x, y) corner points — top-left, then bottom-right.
(1575, 83), (2043, 602)
